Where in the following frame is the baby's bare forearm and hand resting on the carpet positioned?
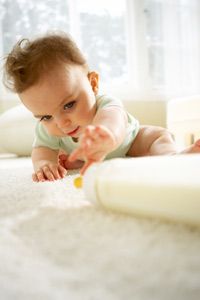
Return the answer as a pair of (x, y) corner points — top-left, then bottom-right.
(32, 147), (67, 182)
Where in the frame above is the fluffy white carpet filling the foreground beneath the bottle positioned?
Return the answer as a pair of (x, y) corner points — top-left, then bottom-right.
(0, 158), (200, 300)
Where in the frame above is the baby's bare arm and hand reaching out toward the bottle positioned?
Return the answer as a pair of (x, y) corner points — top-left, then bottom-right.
(69, 106), (127, 174)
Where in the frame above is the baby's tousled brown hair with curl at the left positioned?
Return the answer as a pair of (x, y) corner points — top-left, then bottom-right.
(4, 32), (88, 93)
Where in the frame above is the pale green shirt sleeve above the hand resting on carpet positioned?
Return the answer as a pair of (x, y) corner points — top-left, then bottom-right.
(33, 122), (60, 150)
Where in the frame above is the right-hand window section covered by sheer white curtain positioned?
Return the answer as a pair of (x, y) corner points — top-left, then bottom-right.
(144, 0), (200, 95)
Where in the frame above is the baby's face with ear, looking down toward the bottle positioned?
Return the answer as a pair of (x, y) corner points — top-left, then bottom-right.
(19, 65), (98, 138)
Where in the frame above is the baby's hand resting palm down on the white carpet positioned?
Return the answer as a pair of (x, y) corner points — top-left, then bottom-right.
(32, 160), (67, 182)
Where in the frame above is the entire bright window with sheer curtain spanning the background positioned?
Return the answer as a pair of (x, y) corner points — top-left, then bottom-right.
(0, 0), (200, 103)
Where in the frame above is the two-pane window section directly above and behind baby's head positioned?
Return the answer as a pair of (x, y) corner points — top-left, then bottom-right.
(1, 0), (127, 91)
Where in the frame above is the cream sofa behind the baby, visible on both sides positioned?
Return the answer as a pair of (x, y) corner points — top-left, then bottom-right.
(0, 96), (200, 156)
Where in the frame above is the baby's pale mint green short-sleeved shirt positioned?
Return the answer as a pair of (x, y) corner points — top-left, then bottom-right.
(33, 95), (139, 159)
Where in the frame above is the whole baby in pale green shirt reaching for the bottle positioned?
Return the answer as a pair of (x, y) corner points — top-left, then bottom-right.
(5, 33), (200, 182)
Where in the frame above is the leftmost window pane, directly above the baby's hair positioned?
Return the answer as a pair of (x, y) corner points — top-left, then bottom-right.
(1, 0), (69, 53)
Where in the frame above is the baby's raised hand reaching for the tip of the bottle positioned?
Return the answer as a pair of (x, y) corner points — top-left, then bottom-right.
(69, 125), (116, 174)
